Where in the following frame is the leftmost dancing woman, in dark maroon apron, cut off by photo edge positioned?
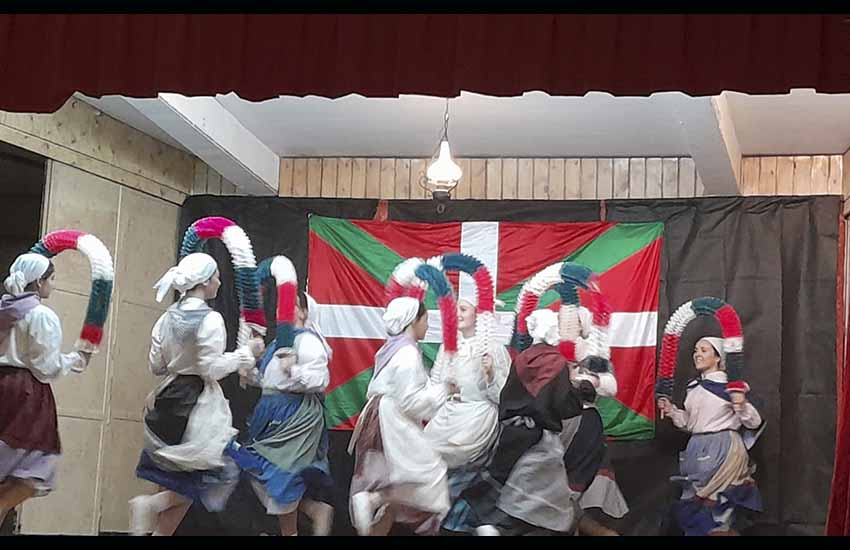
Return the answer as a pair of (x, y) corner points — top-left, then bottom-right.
(0, 254), (91, 524)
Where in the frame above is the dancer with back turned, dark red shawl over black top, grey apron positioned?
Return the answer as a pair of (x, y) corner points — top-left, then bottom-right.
(461, 310), (596, 535)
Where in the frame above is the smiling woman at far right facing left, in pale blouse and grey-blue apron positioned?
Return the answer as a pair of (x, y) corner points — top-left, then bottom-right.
(658, 336), (763, 536)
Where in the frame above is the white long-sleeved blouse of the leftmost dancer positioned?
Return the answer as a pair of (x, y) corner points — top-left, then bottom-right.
(0, 304), (86, 384)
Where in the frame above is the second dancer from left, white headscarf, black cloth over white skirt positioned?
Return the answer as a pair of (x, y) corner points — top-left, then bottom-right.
(130, 253), (264, 536)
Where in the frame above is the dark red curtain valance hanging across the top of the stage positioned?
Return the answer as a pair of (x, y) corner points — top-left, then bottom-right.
(0, 14), (850, 112)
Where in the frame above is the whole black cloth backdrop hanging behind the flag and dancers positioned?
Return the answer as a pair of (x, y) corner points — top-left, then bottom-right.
(171, 196), (840, 535)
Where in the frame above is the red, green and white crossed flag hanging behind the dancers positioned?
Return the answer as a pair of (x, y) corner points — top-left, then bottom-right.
(307, 216), (664, 440)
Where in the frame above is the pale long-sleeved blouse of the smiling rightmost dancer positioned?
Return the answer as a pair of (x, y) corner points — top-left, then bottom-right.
(670, 371), (761, 433)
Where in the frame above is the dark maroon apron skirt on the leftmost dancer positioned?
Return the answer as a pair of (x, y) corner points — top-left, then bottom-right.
(0, 367), (61, 454)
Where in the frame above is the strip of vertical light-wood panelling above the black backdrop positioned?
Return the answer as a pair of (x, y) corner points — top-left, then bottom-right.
(276, 155), (844, 200)
